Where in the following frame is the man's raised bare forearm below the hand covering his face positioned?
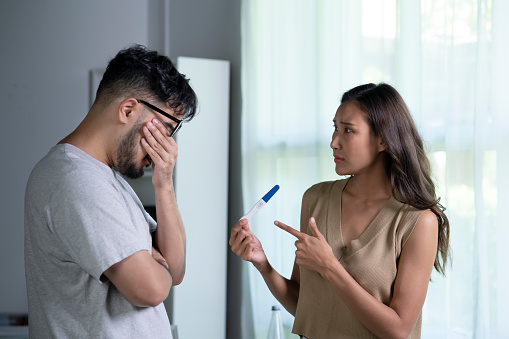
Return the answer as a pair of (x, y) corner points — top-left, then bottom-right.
(154, 186), (186, 285)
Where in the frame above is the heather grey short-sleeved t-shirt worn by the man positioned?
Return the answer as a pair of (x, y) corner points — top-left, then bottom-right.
(25, 144), (171, 338)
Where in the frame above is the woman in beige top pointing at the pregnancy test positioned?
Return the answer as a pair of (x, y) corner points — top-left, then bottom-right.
(230, 84), (449, 339)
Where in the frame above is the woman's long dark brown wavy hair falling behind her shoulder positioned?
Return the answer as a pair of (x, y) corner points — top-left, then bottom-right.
(341, 83), (449, 275)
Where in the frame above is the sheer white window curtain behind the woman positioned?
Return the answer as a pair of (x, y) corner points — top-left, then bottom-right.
(241, 0), (509, 338)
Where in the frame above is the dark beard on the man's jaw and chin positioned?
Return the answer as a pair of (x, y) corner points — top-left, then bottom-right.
(115, 122), (143, 179)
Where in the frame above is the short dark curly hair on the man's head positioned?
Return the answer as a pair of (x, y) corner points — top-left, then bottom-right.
(96, 45), (198, 121)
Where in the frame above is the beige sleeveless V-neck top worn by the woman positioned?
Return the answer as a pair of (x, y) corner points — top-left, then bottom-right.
(292, 179), (424, 339)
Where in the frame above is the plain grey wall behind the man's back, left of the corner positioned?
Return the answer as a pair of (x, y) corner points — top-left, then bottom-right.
(0, 0), (149, 313)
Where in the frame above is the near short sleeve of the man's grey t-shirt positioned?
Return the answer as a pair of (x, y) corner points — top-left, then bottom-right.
(50, 172), (150, 280)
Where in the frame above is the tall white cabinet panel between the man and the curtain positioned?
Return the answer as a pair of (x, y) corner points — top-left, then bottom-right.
(172, 57), (230, 338)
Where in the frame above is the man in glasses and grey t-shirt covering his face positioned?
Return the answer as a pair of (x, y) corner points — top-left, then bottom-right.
(25, 45), (197, 338)
